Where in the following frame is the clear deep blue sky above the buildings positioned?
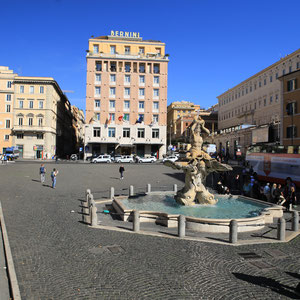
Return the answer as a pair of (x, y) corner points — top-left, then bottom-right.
(0, 0), (300, 109)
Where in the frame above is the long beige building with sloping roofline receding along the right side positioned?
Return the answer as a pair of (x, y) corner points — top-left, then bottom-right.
(216, 49), (300, 155)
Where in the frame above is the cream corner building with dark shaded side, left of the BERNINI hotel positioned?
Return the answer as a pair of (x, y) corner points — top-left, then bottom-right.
(12, 76), (74, 159)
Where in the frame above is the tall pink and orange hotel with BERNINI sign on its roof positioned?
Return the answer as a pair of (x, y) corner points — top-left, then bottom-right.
(85, 31), (169, 158)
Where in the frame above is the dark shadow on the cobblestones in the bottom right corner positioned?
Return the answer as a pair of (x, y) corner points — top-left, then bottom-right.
(232, 273), (299, 299)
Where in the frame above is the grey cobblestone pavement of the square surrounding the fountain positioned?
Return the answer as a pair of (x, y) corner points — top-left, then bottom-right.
(0, 162), (300, 300)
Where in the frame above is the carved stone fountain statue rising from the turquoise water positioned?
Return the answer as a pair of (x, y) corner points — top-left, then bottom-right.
(164, 116), (232, 205)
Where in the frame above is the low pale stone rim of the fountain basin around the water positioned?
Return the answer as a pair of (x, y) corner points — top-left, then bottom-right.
(112, 191), (283, 233)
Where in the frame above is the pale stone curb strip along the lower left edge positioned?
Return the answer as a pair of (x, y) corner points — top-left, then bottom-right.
(0, 201), (21, 300)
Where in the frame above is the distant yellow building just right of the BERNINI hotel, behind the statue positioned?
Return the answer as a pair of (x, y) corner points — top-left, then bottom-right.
(167, 101), (205, 143)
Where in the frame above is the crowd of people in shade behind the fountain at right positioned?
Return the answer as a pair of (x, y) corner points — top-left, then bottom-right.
(216, 168), (297, 211)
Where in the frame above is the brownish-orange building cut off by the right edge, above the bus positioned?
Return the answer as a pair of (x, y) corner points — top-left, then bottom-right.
(279, 68), (300, 146)
